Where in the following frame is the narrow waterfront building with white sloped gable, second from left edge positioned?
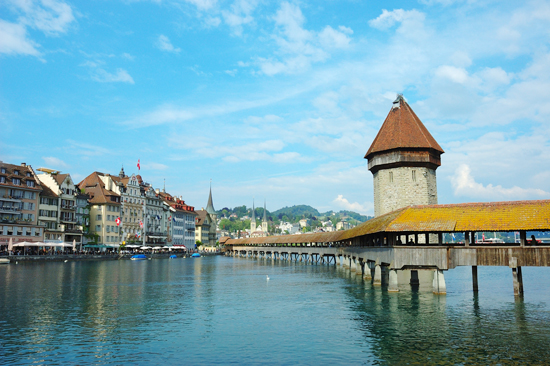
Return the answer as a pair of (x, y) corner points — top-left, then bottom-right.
(37, 168), (82, 245)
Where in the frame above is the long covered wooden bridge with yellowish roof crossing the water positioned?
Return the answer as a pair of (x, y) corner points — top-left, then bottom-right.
(224, 200), (550, 296)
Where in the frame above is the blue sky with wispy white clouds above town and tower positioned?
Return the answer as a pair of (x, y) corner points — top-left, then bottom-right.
(0, 0), (550, 214)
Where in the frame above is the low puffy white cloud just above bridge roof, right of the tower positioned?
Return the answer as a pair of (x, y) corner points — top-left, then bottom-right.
(452, 164), (550, 200)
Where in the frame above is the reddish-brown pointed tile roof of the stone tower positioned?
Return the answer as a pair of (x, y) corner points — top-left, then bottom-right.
(365, 95), (444, 159)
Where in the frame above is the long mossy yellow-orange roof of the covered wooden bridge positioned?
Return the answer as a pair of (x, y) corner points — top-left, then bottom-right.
(227, 200), (550, 245)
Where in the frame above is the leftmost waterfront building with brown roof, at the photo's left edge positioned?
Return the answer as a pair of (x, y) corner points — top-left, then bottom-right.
(0, 161), (44, 245)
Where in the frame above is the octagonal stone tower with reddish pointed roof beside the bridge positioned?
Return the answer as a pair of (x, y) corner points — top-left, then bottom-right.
(365, 94), (444, 217)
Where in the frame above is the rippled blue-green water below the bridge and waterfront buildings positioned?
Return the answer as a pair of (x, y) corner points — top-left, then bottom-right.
(0, 256), (550, 365)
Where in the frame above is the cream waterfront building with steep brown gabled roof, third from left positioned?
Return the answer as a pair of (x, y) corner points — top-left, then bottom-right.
(78, 172), (123, 248)
